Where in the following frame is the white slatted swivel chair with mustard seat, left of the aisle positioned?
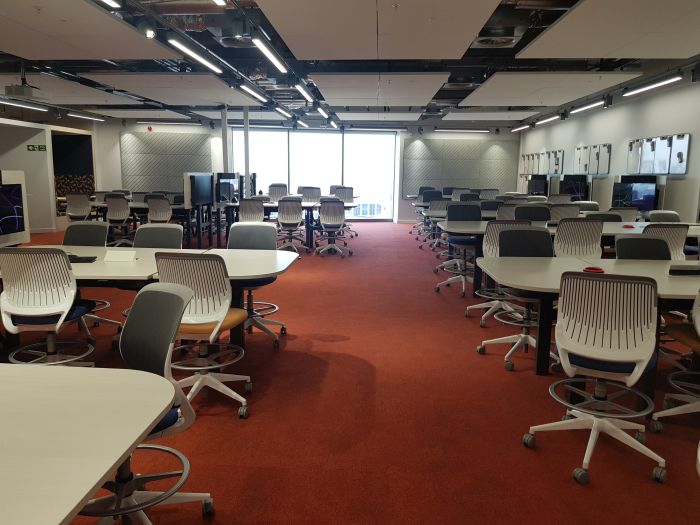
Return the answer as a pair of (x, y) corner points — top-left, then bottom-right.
(156, 252), (253, 419)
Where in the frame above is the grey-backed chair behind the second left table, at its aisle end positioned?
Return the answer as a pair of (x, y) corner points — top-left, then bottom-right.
(228, 223), (287, 348)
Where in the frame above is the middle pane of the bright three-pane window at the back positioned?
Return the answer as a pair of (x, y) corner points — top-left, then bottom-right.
(289, 131), (343, 195)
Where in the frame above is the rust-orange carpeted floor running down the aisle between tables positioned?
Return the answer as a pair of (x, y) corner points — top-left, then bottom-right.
(19, 223), (700, 524)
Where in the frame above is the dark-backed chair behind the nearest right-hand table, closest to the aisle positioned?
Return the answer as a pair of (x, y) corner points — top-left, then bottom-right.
(476, 226), (554, 371)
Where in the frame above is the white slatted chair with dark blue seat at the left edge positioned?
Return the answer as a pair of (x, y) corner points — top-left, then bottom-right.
(0, 248), (95, 366)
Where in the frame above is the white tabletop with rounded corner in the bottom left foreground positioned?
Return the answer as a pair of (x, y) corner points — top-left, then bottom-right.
(0, 364), (175, 525)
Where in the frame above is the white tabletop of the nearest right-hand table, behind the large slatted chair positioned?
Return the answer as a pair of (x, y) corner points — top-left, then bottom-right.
(477, 257), (700, 300)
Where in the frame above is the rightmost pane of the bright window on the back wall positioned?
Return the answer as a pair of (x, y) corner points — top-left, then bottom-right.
(344, 132), (396, 219)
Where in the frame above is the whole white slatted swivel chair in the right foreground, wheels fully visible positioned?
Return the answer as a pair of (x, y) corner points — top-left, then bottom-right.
(522, 272), (666, 484)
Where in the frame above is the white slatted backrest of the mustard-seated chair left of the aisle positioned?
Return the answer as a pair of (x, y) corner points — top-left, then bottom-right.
(154, 252), (231, 343)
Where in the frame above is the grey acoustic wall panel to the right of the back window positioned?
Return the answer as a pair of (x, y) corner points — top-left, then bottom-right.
(401, 138), (519, 195)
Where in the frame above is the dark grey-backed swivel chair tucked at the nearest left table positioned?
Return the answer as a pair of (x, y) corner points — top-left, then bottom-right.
(80, 283), (214, 525)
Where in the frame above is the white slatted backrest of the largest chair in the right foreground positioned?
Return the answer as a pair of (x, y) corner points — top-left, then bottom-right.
(555, 272), (657, 386)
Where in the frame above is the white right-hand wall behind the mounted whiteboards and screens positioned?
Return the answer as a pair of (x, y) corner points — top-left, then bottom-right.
(520, 80), (700, 222)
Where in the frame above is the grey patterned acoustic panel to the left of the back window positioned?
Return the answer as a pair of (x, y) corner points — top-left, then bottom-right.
(120, 132), (212, 192)
